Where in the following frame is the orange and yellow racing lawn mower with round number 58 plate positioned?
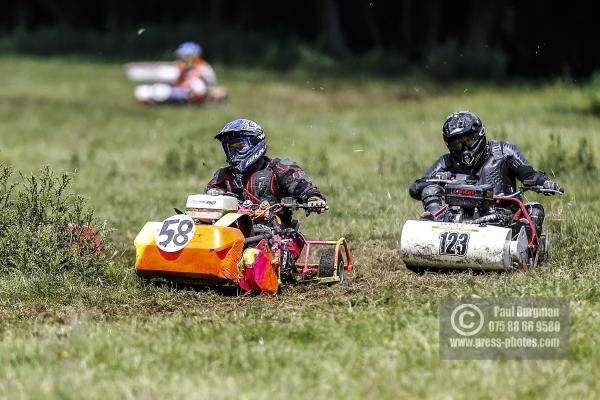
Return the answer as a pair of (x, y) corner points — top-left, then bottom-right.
(134, 193), (352, 294)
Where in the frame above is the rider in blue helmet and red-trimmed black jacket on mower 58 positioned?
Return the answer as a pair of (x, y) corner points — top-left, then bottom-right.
(205, 119), (326, 223)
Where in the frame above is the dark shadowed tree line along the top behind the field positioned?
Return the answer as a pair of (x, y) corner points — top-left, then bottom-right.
(0, 0), (599, 79)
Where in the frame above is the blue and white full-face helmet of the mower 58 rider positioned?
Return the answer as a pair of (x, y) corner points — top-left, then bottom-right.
(215, 118), (267, 172)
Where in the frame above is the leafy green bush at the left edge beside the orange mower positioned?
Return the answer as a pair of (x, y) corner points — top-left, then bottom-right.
(0, 165), (107, 283)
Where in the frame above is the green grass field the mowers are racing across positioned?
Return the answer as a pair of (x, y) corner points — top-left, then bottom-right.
(0, 58), (600, 399)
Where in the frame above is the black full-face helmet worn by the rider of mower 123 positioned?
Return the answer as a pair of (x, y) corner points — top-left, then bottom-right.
(442, 111), (486, 167)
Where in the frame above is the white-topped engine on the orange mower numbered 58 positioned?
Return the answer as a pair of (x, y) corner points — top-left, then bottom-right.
(185, 194), (238, 225)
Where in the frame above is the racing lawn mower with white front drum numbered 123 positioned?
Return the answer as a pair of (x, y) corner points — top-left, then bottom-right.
(400, 177), (562, 272)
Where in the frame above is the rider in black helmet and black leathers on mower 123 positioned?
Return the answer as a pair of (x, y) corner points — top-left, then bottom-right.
(409, 111), (564, 233)
